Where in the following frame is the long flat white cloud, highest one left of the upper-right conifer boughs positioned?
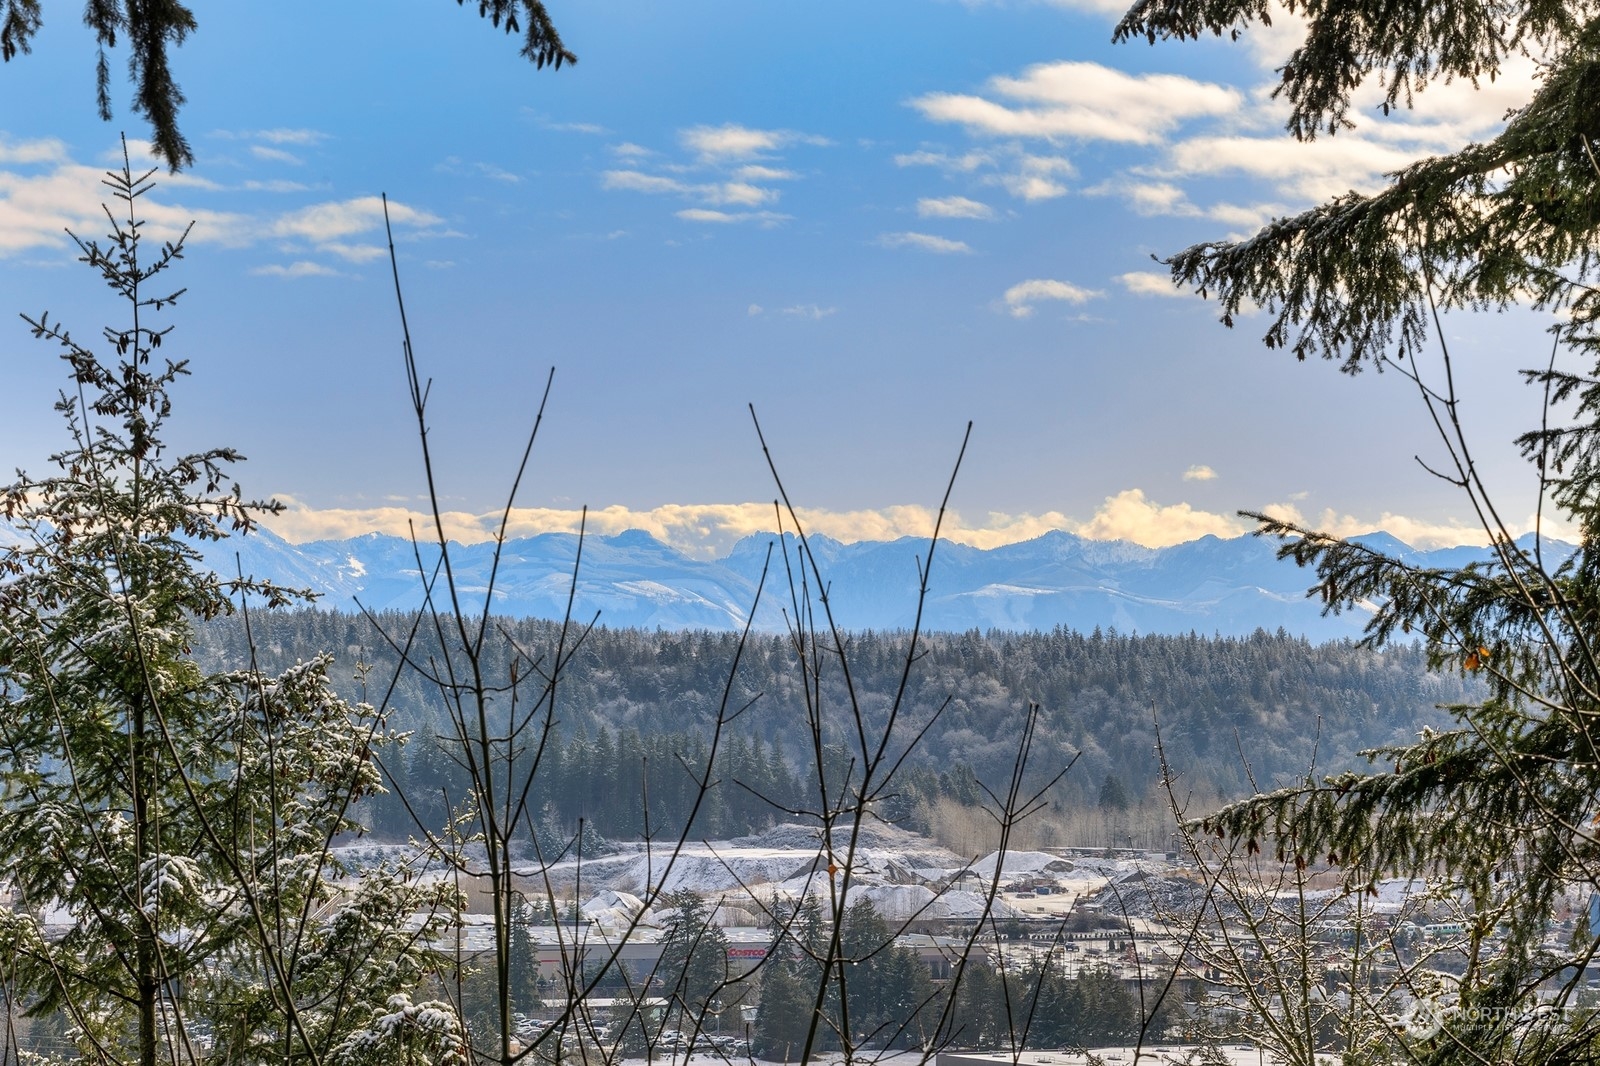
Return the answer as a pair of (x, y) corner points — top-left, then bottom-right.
(912, 62), (1243, 144)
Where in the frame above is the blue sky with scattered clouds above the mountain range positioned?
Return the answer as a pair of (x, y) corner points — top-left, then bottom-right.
(0, 0), (1547, 552)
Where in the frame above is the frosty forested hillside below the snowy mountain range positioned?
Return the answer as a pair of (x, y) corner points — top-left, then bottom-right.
(197, 610), (1469, 837)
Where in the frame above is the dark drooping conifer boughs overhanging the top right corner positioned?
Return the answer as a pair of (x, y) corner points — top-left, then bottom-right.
(1115, 0), (1600, 371)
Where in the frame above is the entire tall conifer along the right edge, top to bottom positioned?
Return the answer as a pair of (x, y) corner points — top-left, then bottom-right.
(1117, 0), (1600, 1063)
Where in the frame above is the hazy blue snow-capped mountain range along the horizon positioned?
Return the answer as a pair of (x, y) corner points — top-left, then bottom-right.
(181, 530), (1570, 640)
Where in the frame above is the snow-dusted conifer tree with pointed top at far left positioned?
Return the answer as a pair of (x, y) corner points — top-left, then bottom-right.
(0, 145), (458, 1066)
